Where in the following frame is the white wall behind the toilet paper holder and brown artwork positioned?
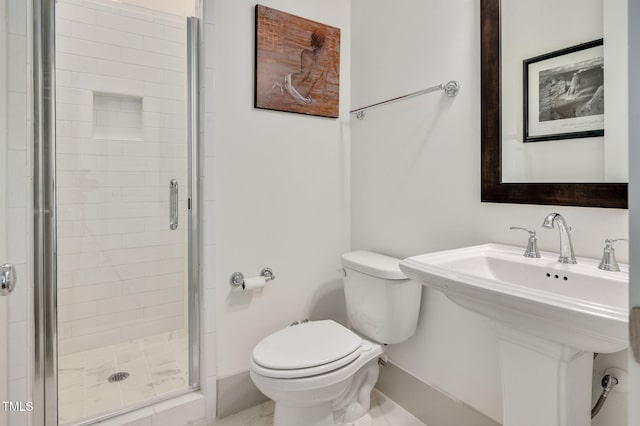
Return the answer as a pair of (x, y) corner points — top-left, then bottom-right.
(209, 0), (350, 376)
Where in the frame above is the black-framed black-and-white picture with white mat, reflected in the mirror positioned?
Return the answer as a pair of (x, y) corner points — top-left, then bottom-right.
(523, 39), (604, 142)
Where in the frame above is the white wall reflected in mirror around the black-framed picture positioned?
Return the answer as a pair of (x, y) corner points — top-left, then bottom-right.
(500, 0), (604, 182)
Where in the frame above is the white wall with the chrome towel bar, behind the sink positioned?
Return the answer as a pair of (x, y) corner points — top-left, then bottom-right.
(351, 0), (628, 421)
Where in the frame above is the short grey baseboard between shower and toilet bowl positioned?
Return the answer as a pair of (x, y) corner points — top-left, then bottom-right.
(216, 371), (269, 419)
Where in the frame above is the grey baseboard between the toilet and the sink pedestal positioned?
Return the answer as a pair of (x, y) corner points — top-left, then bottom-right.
(376, 362), (500, 426)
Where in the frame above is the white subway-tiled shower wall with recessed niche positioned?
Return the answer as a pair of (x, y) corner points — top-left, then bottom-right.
(56, 0), (187, 355)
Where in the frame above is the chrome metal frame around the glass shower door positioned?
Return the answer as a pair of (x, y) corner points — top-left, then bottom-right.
(32, 0), (201, 426)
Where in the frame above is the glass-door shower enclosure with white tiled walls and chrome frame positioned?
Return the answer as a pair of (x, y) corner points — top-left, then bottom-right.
(34, 0), (199, 425)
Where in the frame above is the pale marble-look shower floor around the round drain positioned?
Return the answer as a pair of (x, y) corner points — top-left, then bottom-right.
(58, 330), (189, 425)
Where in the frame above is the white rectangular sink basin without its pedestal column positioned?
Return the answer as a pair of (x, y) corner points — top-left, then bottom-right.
(400, 244), (629, 353)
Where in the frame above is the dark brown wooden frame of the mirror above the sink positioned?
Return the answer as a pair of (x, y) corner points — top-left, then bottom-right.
(480, 0), (628, 209)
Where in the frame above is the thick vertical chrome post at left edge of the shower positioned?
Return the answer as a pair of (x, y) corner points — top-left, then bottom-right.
(33, 0), (58, 426)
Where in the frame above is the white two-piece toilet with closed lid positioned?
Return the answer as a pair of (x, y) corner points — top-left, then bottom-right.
(250, 251), (422, 426)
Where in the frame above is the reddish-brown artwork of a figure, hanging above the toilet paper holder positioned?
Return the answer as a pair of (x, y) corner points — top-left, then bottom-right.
(254, 5), (340, 118)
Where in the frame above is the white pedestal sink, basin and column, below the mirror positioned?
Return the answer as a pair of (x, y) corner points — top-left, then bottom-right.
(400, 244), (629, 426)
